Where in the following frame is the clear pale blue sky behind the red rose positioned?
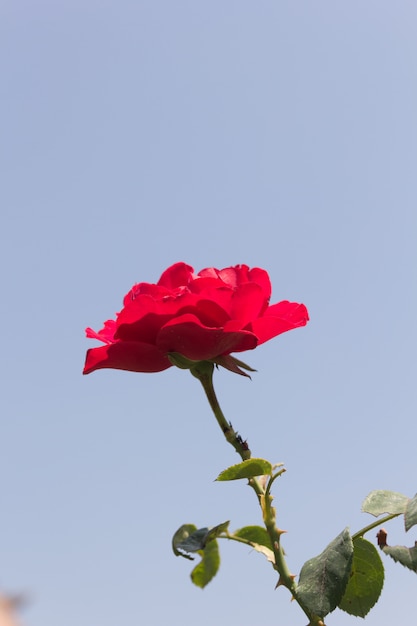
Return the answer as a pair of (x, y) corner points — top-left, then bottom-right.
(0, 0), (417, 626)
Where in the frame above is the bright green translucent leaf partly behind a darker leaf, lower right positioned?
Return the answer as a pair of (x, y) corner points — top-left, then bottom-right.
(339, 537), (384, 617)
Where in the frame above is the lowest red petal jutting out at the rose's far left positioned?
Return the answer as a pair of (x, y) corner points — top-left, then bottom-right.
(83, 341), (171, 374)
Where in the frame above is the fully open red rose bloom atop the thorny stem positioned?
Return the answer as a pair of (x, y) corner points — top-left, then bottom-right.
(84, 263), (308, 374)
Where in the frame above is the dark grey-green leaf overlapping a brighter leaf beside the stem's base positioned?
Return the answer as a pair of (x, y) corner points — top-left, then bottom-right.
(295, 528), (353, 618)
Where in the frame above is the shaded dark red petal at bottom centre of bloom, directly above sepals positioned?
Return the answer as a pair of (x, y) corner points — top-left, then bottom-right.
(156, 313), (258, 361)
